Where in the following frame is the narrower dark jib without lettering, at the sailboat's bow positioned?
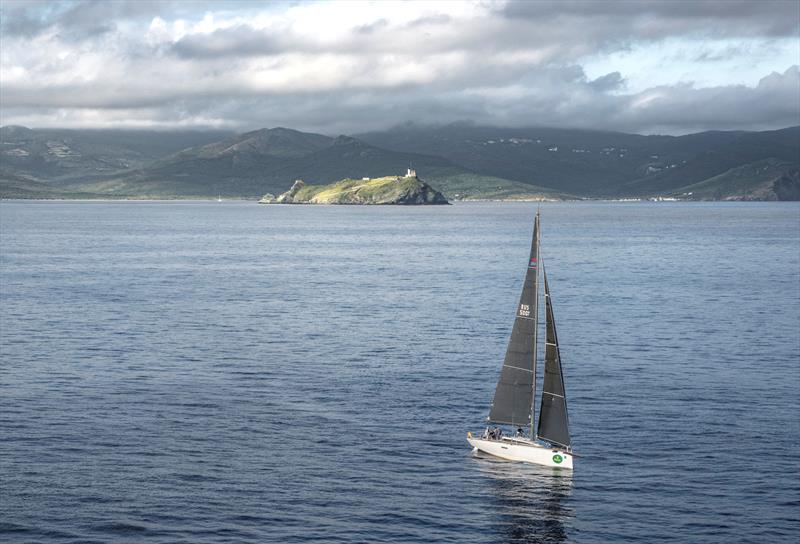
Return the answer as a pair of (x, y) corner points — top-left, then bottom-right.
(537, 267), (570, 448)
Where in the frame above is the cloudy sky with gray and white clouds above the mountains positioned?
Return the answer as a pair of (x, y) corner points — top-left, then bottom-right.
(0, 0), (800, 135)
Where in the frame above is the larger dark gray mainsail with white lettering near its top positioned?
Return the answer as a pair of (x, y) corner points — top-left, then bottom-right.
(489, 214), (539, 434)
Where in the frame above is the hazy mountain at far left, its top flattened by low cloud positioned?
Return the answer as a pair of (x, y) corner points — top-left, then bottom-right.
(0, 126), (231, 183)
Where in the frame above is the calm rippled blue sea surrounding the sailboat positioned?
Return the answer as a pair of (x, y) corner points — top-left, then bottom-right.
(0, 202), (800, 543)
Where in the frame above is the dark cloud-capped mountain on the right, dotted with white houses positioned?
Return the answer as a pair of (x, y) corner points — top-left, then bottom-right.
(358, 123), (800, 197)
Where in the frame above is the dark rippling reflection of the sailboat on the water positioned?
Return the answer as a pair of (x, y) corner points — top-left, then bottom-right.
(475, 455), (573, 543)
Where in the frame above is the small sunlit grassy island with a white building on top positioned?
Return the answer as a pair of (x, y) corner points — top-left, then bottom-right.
(259, 168), (449, 205)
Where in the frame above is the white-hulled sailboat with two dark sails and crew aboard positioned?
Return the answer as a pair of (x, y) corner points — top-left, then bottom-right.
(467, 212), (574, 469)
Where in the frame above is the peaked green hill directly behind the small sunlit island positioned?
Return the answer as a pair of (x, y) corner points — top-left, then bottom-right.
(70, 128), (552, 198)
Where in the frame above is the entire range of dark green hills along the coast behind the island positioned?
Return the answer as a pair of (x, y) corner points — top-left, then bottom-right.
(0, 123), (800, 200)
